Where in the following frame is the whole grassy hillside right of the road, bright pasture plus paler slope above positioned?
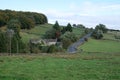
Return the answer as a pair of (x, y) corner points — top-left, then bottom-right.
(78, 31), (120, 53)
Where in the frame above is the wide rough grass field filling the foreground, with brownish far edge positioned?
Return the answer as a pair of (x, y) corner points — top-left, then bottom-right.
(0, 53), (120, 80)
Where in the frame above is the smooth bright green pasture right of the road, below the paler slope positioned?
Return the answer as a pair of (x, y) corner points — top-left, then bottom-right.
(79, 39), (120, 53)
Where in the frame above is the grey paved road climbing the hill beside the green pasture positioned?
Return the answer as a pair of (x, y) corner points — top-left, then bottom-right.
(67, 33), (92, 53)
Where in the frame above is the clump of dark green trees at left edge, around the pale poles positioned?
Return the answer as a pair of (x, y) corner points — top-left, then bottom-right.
(0, 20), (25, 54)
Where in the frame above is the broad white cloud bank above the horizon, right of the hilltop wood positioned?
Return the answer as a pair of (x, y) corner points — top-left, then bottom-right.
(32, 1), (120, 29)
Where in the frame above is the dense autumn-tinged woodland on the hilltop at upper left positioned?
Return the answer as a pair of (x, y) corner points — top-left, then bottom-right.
(0, 10), (48, 29)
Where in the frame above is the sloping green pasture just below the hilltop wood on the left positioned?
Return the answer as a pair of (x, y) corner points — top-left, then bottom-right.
(20, 24), (52, 43)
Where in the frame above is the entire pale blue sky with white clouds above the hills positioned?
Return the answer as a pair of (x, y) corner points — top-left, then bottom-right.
(0, 0), (120, 30)
